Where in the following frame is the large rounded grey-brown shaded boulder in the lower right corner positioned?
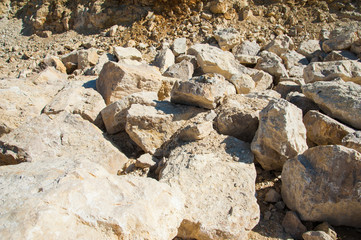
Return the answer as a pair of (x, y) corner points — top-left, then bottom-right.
(282, 145), (361, 227)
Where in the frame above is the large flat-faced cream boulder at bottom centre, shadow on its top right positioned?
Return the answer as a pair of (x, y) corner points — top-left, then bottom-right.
(159, 132), (259, 240)
